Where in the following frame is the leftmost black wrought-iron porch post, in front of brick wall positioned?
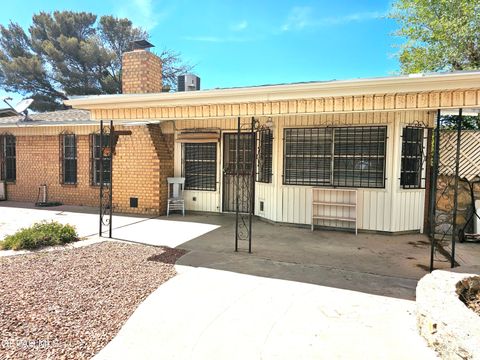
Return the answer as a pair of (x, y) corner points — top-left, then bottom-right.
(99, 121), (115, 238)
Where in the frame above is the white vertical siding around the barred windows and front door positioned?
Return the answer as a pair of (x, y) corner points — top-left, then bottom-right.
(175, 111), (434, 232)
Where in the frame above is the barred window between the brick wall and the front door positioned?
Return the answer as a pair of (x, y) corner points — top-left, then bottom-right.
(182, 142), (218, 191)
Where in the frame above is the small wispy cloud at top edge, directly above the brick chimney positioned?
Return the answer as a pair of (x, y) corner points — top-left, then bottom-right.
(116, 0), (167, 31)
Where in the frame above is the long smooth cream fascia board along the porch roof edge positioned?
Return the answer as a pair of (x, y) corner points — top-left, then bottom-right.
(64, 71), (480, 110)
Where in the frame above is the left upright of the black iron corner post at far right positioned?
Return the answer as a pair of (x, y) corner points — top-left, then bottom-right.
(430, 109), (442, 272)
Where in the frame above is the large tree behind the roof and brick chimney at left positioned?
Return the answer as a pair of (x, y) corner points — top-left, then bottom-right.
(0, 11), (191, 111)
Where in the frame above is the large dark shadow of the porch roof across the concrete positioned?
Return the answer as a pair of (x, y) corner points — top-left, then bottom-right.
(167, 214), (464, 300)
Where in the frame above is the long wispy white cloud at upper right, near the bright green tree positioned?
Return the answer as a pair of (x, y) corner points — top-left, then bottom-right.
(281, 6), (385, 31)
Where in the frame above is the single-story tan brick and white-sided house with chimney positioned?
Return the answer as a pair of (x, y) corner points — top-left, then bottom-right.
(0, 45), (480, 233)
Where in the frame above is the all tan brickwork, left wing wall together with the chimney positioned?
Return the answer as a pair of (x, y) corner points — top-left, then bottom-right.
(0, 50), (174, 215)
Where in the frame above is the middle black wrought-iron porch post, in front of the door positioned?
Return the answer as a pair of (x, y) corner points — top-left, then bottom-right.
(235, 117), (273, 253)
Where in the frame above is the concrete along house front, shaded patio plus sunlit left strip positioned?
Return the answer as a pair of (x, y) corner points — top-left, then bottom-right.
(0, 202), (480, 300)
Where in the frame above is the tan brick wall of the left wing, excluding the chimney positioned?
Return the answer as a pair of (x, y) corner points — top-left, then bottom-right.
(7, 124), (173, 215)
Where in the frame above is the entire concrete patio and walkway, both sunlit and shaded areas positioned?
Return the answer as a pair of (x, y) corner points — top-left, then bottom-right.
(0, 202), (480, 359)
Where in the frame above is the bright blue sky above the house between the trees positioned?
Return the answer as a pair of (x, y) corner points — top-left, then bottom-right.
(0, 0), (399, 105)
